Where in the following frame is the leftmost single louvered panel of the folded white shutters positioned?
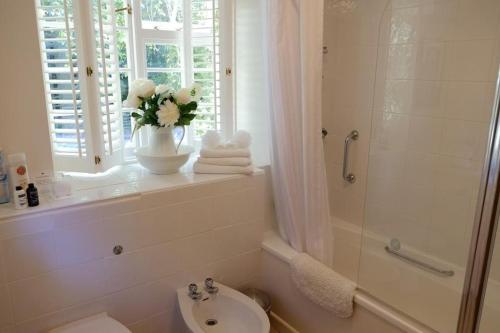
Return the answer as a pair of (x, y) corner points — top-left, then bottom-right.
(36, 0), (89, 171)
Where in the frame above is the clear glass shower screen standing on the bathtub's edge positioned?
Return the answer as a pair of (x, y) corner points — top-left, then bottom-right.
(358, 0), (500, 332)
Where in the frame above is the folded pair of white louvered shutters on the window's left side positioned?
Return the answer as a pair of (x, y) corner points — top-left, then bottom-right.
(36, 0), (123, 172)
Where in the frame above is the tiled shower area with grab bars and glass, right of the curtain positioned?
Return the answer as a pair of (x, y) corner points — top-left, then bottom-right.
(323, 0), (500, 333)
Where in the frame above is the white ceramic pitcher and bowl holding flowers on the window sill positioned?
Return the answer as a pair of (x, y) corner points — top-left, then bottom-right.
(136, 126), (194, 175)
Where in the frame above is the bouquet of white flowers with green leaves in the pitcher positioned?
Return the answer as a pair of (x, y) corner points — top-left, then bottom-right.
(124, 79), (201, 132)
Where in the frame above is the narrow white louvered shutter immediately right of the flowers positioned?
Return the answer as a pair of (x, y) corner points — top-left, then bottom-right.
(191, 0), (221, 137)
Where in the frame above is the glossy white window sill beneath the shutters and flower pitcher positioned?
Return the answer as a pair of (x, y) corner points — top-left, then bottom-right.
(0, 164), (263, 220)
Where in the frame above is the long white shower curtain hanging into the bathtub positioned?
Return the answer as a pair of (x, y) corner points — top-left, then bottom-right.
(263, 0), (333, 265)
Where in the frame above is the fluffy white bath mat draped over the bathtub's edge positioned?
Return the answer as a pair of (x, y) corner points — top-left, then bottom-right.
(290, 253), (356, 318)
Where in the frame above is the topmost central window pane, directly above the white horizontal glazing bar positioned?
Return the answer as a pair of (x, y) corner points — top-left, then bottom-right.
(141, 0), (183, 31)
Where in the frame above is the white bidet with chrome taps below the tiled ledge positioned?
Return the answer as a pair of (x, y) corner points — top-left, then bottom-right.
(177, 284), (270, 333)
